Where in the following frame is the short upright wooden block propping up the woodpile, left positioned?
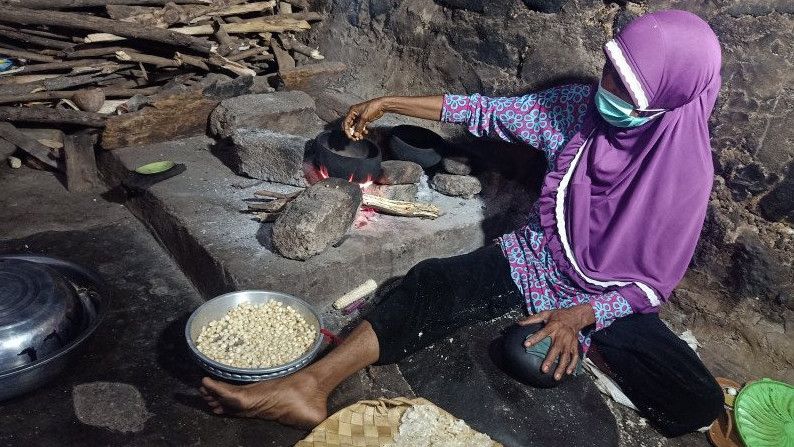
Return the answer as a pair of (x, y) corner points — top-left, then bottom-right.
(63, 131), (102, 192)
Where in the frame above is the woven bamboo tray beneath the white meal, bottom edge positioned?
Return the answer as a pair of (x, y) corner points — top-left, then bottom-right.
(295, 397), (502, 447)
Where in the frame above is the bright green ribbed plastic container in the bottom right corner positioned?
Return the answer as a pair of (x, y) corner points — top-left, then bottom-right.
(733, 379), (794, 447)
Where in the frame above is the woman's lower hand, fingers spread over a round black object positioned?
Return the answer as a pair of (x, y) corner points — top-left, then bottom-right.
(518, 304), (595, 380)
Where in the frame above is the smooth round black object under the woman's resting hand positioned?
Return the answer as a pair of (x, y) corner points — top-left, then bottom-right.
(502, 324), (560, 388)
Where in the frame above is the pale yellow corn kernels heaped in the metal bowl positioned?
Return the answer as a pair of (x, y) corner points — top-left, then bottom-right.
(196, 300), (317, 368)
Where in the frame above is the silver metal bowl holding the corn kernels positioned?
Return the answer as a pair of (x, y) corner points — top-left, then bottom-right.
(185, 290), (323, 382)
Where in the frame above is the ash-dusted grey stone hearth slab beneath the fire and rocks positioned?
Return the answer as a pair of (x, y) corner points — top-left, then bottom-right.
(96, 137), (515, 316)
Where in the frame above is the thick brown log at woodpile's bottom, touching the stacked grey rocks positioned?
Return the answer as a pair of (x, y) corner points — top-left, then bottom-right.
(102, 91), (220, 149)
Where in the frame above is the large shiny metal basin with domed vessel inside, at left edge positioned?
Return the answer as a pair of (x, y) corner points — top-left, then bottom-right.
(0, 255), (107, 401)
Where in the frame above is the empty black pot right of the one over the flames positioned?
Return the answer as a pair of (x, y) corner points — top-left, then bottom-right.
(389, 124), (444, 169)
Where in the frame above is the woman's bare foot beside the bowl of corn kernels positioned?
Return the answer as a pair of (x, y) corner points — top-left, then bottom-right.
(200, 371), (328, 428)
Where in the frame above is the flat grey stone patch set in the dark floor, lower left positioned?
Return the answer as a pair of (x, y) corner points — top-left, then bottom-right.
(72, 382), (151, 433)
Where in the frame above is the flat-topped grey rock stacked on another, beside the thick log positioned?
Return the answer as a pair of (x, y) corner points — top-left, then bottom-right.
(210, 91), (322, 138)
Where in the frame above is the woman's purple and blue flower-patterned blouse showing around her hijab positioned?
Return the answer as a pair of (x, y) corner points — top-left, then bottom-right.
(441, 84), (632, 352)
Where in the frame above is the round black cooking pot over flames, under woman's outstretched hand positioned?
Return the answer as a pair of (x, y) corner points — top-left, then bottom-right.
(314, 130), (382, 183)
